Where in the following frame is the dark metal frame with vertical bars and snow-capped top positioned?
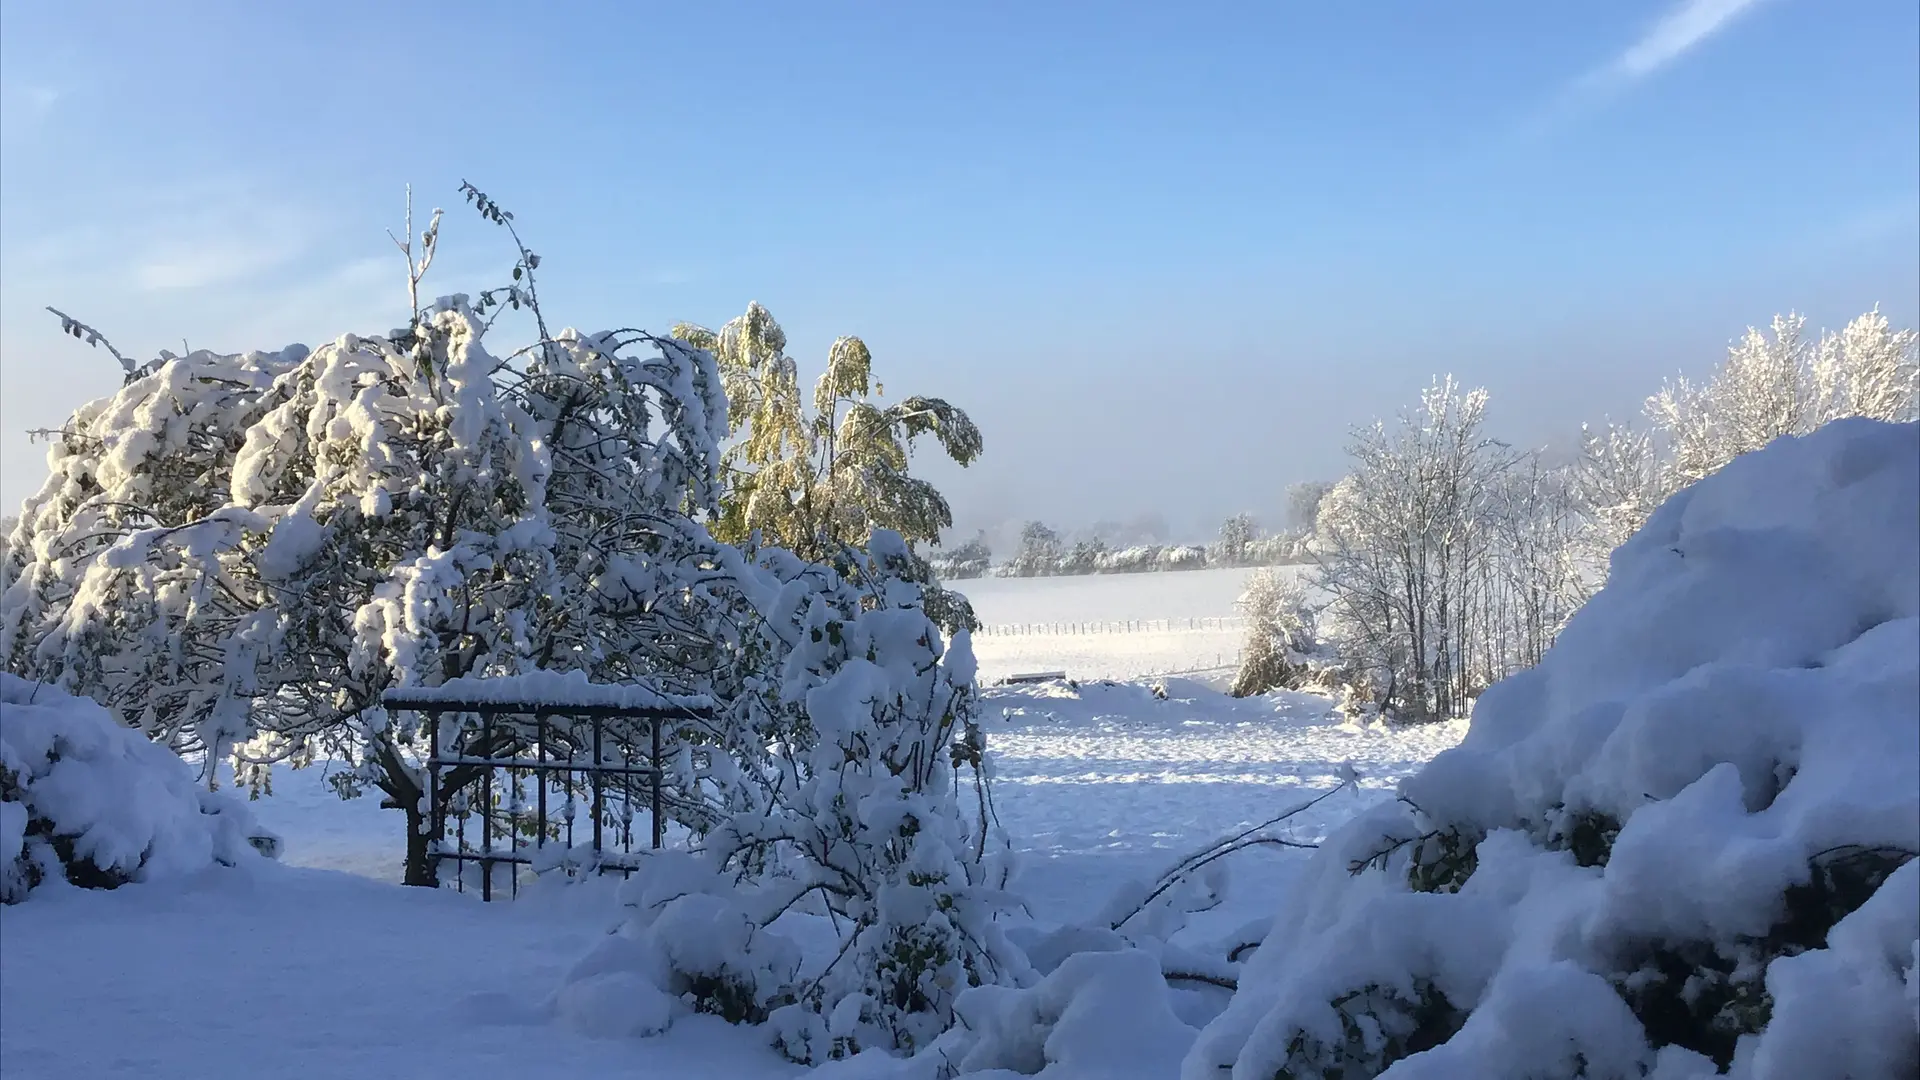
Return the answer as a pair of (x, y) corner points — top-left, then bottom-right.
(380, 688), (708, 901)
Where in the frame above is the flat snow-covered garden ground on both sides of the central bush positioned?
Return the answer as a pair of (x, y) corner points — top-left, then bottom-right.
(0, 676), (1465, 1080)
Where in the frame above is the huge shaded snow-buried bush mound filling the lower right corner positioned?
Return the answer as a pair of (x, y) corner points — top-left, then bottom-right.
(1183, 421), (1920, 1080)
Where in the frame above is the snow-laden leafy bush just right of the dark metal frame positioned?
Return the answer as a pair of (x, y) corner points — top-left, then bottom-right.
(555, 530), (1025, 1061)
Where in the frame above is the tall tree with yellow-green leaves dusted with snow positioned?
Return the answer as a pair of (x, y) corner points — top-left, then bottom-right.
(674, 304), (983, 559)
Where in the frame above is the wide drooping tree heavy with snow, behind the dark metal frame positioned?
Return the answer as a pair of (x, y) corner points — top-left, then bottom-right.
(0, 192), (726, 884)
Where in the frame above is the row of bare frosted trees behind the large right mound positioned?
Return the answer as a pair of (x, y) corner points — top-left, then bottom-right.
(1313, 309), (1920, 721)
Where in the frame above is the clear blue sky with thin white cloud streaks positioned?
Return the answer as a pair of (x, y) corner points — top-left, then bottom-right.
(0, 0), (1920, 538)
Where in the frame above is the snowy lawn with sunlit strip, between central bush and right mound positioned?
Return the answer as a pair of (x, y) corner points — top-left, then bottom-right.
(987, 680), (1467, 930)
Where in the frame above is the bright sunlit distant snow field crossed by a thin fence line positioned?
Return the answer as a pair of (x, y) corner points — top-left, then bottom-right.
(952, 567), (1300, 682)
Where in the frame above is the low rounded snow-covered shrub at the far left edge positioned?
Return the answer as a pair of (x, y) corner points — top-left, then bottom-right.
(0, 673), (278, 903)
